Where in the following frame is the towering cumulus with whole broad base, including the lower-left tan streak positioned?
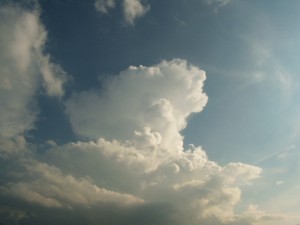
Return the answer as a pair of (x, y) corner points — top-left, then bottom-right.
(1, 48), (277, 224)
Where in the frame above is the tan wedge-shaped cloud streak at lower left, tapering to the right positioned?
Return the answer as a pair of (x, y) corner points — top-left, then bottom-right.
(1, 159), (143, 207)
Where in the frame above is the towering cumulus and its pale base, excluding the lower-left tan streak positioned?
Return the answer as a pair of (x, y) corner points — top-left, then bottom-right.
(55, 59), (284, 224)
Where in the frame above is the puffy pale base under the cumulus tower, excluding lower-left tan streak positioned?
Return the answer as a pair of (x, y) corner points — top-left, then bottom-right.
(35, 134), (268, 224)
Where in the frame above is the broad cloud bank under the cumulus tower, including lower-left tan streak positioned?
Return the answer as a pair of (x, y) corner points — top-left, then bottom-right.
(0, 134), (260, 224)
